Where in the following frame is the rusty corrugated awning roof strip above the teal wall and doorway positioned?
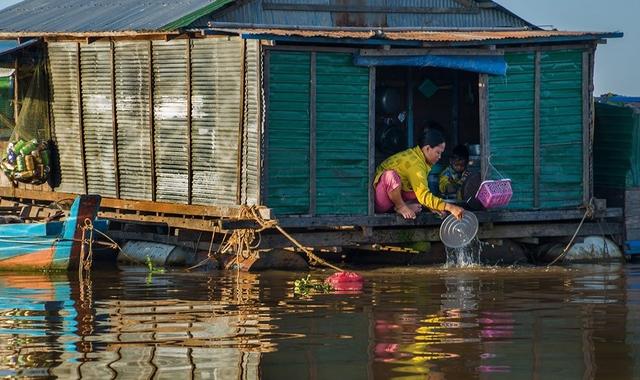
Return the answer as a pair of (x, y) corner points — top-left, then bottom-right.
(211, 28), (622, 44)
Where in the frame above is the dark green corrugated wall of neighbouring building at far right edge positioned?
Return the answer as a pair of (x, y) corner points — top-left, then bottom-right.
(593, 103), (640, 189)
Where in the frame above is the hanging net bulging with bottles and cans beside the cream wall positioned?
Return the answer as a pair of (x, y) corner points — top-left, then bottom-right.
(0, 60), (51, 185)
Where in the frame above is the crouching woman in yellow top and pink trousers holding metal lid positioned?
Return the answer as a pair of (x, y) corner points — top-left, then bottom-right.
(373, 128), (464, 219)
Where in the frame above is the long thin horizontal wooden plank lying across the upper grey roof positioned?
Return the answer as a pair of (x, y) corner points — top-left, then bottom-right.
(262, 1), (480, 14)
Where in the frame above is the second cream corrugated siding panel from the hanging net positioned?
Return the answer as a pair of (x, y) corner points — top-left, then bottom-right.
(80, 42), (117, 198)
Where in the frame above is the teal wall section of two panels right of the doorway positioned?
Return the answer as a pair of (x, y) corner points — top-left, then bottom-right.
(488, 50), (583, 209)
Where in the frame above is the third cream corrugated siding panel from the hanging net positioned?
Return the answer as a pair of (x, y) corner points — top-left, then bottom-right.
(115, 41), (153, 200)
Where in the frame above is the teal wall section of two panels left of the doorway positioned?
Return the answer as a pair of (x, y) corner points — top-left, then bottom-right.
(266, 50), (369, 215)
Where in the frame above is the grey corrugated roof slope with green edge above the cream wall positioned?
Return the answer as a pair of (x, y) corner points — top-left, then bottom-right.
(0, 0), (233, 34)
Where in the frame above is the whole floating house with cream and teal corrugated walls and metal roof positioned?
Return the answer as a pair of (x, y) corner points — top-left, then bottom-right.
(0, 0), (622, 260)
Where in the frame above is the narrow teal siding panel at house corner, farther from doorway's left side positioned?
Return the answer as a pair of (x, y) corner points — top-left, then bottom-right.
(266, 51), (311, 214)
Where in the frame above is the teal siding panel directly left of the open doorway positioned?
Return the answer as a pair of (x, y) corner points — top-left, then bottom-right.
(316, 53), (369, 215)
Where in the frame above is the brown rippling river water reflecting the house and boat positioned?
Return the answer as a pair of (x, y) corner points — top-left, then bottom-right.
(0, 264), (640, 380)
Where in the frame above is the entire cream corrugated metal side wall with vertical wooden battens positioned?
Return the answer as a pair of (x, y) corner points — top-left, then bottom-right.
(49, 37), (261, 205)
